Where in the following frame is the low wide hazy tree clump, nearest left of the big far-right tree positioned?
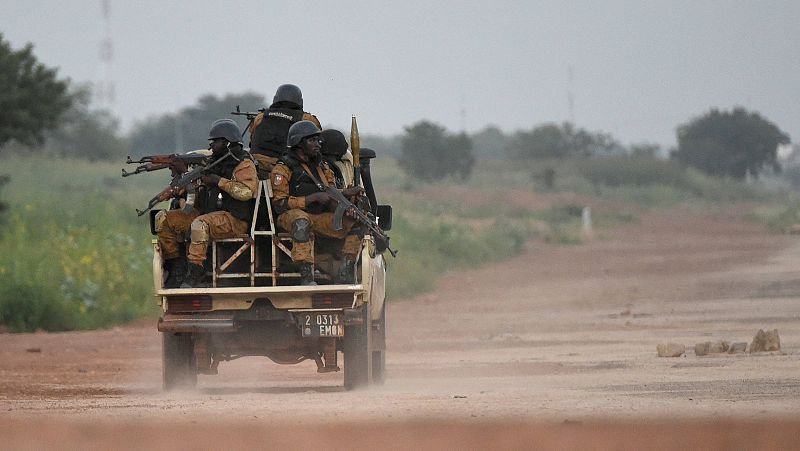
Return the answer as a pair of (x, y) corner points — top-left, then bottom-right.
(507, 122), (623, 160)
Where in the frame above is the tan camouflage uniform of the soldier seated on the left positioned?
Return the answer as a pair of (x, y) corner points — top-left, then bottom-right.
(155, 159), (258, 266)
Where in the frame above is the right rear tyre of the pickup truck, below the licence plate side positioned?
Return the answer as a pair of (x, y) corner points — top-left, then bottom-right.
(342, 305), (372, 390)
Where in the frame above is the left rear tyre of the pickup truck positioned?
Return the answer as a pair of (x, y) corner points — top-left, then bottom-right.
(161, 332), (197, 391)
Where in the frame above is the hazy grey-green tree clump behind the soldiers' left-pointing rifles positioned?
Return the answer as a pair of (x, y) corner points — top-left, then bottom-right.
(130, 93), (264, 155)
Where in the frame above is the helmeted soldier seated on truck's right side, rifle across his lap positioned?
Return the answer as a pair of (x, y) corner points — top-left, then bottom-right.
(270, 121), (363, 285)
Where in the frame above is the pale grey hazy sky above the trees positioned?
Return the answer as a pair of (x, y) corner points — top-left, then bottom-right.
(0, 0), (800, 146)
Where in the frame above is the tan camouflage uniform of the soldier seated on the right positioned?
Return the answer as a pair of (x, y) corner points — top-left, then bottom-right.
(270, 153), (361, 263)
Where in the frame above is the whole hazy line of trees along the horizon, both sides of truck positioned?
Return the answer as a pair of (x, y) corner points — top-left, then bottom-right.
(0, 34), (790, 186)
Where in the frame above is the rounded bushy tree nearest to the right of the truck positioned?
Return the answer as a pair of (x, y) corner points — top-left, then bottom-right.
(399, 120), (475, 181)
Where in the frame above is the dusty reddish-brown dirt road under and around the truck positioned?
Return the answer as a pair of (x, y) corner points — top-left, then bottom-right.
(0, 210), (800, 449)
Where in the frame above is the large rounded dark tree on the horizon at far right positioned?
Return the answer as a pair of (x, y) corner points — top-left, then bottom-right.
(671, 108), (789, 179)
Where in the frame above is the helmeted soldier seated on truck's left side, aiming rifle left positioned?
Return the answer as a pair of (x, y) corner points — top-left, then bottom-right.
(155, 119), (258, 288)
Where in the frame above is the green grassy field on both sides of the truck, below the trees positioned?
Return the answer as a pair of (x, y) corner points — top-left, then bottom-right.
(0, 158), (798, 331)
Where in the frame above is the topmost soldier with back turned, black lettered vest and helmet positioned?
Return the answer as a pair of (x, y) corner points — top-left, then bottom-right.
(248, 85), (321, 179)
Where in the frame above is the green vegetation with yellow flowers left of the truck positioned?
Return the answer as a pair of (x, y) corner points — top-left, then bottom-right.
(0, 158), (160, 331)
